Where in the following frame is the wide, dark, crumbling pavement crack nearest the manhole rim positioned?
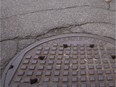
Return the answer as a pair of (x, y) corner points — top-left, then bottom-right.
(0, 22), (115, 42)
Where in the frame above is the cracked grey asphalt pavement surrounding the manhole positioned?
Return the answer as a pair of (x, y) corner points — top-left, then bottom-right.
(0, 0), (116, 83)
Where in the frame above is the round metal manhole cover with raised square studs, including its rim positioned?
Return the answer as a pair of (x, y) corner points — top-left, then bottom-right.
(3, 34), (116, 87)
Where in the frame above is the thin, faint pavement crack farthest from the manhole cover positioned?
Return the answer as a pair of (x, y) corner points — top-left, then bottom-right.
(0, 5), (115, 19)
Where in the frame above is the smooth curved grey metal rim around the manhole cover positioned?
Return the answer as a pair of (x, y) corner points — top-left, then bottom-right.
(2, 33), (115, 87)
